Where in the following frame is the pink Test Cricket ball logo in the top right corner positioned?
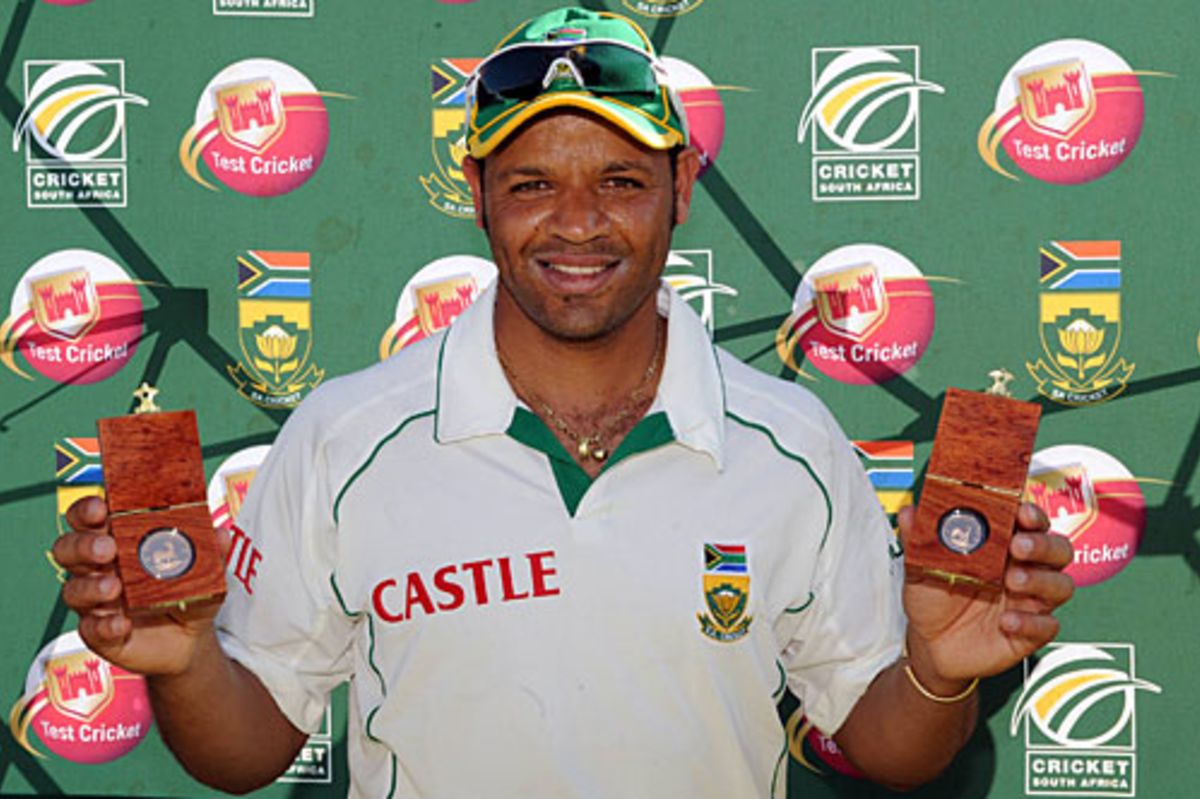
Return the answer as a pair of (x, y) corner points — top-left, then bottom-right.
(979, 38), (1144, 184)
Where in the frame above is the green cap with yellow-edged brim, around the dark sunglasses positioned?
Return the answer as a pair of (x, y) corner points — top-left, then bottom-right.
(467, 7), (688, 158)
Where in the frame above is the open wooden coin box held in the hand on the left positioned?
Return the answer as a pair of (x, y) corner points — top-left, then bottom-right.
(96, 410), (226, 614)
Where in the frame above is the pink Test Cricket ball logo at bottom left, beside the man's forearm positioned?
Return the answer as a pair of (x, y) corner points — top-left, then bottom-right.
(8, 631), (154, 764)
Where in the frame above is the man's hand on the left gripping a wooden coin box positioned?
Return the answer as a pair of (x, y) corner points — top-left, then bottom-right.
(54, 497), (229, 674)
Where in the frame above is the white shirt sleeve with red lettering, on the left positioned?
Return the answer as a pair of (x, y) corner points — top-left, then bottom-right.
(216, 405), (356, 733)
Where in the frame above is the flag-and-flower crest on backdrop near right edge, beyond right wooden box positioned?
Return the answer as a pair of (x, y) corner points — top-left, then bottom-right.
(1025, 241), (1135, 405)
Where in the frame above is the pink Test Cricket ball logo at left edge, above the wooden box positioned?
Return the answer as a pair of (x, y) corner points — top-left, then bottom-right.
(0, 250), (143, 384)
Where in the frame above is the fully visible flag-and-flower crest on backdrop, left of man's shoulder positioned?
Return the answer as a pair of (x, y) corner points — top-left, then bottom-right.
(227, 250), (325, 408)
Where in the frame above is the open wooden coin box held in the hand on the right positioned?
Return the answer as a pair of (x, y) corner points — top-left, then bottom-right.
(905, 389), (1042, 589)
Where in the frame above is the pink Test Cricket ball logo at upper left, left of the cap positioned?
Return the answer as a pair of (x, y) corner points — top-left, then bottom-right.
(179, 59), (336, 197)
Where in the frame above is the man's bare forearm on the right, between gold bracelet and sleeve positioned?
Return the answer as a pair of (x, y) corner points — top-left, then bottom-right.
(834, 653), (979, 789)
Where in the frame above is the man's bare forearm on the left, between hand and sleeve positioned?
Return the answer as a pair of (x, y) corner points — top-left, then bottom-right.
(148, 632), (307, 793)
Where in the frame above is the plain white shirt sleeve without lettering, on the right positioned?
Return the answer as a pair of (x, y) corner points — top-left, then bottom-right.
(782, 429), (906, 734)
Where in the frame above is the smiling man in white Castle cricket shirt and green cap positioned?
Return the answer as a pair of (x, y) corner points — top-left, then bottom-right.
(55, 8), (1072, 798)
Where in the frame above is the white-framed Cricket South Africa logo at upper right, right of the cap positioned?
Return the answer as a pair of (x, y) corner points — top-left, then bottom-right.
(797, 46), (944, 203)
